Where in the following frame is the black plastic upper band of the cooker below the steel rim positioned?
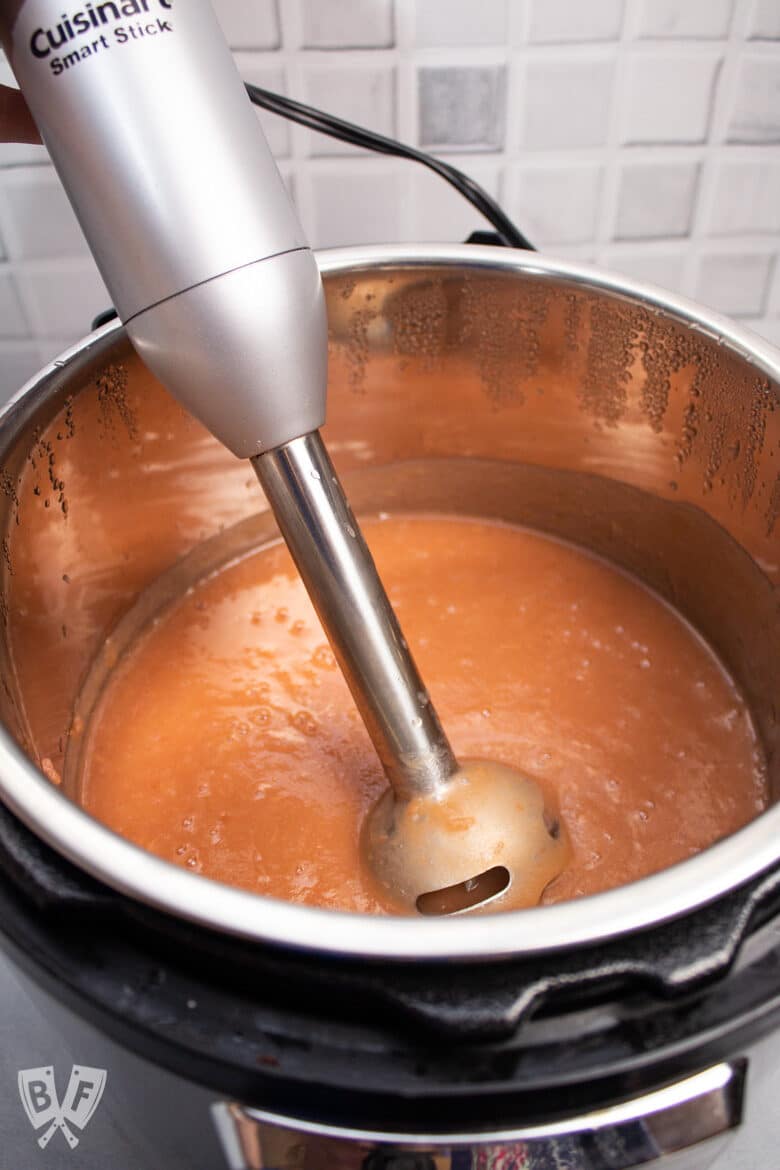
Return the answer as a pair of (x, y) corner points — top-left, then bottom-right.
(0, 806), (780, 1133)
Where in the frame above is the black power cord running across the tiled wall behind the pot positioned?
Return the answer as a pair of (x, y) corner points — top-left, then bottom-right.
(247, 84), (536, 252)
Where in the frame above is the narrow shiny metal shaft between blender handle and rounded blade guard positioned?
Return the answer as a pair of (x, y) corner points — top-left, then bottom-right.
(251, 431), (457, 799)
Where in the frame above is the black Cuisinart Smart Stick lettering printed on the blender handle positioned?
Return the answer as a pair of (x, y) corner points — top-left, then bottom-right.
(29, 0), (173, 77)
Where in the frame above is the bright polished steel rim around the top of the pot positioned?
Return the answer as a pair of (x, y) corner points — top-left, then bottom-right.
(0, 245), (780, 961)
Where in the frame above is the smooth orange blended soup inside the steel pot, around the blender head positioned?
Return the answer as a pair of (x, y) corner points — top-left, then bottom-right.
(81, 516), (767, 914)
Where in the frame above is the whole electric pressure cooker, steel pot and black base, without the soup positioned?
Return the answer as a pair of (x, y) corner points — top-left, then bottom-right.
(0, 246), (780, 1170)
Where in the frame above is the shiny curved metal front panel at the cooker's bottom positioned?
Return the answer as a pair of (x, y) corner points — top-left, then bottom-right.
(212, 1059), (747, 1170)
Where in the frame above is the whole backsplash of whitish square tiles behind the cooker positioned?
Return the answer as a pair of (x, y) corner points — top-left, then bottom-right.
(0, 0), (780, 393)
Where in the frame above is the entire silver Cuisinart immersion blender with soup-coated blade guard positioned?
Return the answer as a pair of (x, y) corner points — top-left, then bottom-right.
(0, 0), (567, 914)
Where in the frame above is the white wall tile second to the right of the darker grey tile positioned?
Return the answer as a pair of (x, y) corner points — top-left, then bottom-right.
(622, 50), (722, 145)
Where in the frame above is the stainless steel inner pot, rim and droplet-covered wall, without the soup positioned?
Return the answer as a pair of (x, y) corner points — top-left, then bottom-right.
(0, 246), (780, 958)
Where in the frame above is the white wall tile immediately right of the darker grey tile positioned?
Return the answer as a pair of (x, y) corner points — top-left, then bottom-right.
(520, 53), (615, 151)
